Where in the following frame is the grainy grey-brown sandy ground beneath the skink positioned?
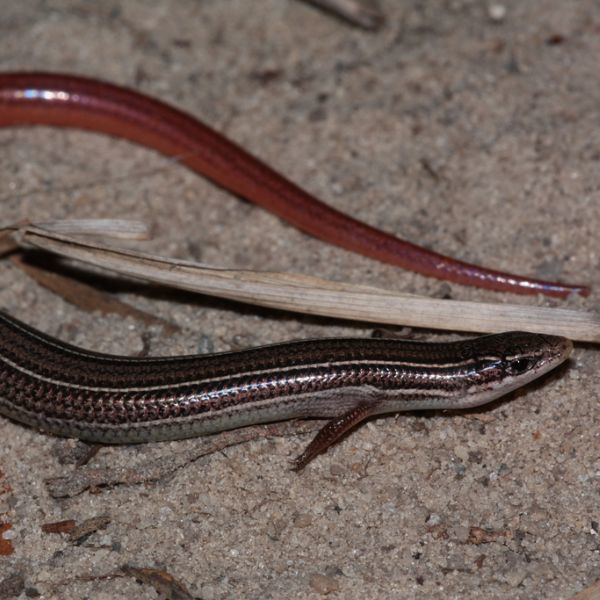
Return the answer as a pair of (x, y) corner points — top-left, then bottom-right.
(0, 0), (600, 600)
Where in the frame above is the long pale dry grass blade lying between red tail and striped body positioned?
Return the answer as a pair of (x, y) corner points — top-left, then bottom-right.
(14, 226), (600, 343)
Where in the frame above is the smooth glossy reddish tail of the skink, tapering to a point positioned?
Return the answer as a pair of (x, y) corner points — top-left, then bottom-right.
(0, 73), (589, 297)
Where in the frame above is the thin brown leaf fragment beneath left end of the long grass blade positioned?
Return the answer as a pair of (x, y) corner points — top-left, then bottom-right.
(11, 255), (179, 335)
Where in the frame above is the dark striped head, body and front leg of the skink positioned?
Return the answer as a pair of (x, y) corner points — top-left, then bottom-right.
(0, 313), (572, 469)
